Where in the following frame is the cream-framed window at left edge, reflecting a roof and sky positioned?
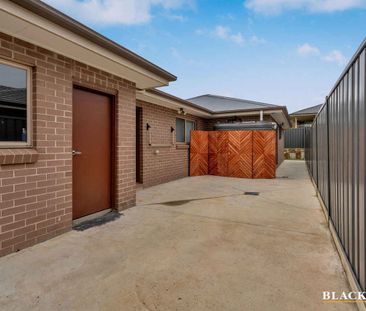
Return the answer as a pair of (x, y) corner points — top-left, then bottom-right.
(0, 60), (31, 147)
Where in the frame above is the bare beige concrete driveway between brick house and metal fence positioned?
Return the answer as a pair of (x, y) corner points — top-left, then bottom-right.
(0, 161), (356, 311)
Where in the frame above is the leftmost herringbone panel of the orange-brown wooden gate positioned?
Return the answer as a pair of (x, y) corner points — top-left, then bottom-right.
(189, 131), (208, 176)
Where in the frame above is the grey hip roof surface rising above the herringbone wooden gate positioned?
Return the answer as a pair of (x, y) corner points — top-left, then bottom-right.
(187, 94), (280, 112)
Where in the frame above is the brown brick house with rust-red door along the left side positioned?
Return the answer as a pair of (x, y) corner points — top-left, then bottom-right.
(0, 0), (288, 256)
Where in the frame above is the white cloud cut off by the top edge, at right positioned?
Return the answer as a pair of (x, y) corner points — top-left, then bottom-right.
(244, 0), (366, 15)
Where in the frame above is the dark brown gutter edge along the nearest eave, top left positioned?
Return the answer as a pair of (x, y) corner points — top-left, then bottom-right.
(4, 0), (177, 81)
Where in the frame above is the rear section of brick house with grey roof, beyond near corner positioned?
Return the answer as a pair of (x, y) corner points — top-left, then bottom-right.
(136, 90), (290, 187)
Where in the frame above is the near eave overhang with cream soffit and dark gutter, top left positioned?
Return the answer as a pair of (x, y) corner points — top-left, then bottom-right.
(0, 0), (177, 88)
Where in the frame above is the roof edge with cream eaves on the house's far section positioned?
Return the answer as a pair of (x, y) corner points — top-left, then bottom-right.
(137, 89), (291, 128)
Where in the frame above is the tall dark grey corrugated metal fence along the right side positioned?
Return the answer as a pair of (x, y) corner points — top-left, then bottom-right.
(305, 41), (366, 290)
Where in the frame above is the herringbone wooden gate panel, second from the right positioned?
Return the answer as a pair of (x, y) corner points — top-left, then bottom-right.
(228, 131), (253, 178)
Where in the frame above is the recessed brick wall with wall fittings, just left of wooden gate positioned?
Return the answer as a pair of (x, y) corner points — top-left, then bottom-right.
(137, 101), (206, 187)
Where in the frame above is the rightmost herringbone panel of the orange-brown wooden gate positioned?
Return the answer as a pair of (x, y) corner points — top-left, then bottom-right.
(253, 130), (276, 178)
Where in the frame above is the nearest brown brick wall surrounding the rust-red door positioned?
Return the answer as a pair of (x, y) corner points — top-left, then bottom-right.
(0, 33), (136, 256)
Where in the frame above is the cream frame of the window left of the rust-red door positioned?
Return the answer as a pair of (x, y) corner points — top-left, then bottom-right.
(0, 59), (33, 149)
